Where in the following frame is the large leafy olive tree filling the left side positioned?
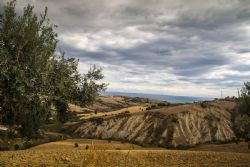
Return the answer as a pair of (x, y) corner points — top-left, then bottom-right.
(0, 1), (106, 136)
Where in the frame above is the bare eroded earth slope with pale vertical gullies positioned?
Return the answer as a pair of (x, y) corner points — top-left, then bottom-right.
(74, 101), (235, 147)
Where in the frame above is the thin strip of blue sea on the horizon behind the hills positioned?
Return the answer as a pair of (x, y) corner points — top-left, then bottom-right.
(104, 91), (214, 103)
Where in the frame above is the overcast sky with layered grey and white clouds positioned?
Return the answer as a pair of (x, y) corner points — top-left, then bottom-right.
(0, 0), (250, 97)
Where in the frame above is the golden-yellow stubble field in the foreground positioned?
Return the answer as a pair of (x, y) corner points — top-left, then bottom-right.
(0, 140), (250, 167)
